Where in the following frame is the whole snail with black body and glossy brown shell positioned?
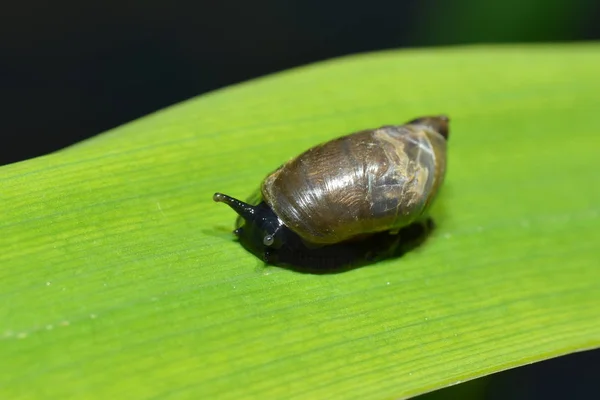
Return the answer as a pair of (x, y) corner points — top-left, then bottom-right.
(213, 115), (449, 270)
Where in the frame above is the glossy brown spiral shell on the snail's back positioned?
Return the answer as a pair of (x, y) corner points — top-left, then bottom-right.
(261, 123), (446, 244)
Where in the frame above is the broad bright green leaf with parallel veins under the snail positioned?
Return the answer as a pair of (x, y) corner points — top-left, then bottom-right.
(0, 44), (600, 400)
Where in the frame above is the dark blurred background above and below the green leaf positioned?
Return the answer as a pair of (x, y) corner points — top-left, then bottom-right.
(0, 0), (600, 399)
